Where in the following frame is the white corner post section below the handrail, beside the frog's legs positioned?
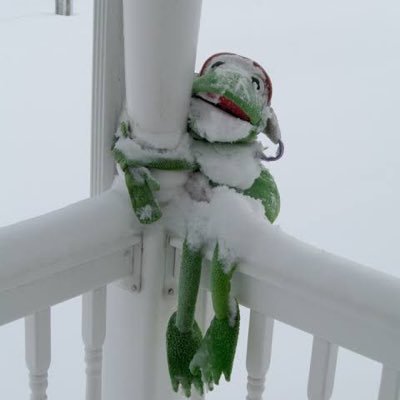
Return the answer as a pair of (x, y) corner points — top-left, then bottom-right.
(104, 226), (176, 400)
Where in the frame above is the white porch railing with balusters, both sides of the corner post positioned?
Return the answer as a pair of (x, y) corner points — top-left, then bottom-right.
(0, 190), (400, 400)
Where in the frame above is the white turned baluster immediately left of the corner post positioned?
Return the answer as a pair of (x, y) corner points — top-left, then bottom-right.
(82, 287), (106, 400)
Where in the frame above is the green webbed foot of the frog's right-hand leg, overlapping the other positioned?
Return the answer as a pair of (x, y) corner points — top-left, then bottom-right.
(190, 299), (240, 390)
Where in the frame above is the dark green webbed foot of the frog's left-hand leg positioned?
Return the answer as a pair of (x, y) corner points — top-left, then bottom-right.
(167, 313), (203, 397)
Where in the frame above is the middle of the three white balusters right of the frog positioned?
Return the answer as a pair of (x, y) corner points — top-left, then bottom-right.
(308, 337), (338, 400)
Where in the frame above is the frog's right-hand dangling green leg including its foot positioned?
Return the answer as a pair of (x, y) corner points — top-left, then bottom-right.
(190, 244), (240, 389)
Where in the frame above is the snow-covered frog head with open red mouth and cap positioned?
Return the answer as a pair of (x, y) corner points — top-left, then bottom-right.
(189, 53), (282, 160)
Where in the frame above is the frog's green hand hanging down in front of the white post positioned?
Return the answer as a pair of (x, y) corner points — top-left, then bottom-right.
(125, 167), (161, 224)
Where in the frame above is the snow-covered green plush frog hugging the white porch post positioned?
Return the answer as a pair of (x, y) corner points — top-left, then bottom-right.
(113, 53), (283, 397)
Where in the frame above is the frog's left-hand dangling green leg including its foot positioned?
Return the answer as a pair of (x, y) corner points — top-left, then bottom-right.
(167, 240), (203, 397)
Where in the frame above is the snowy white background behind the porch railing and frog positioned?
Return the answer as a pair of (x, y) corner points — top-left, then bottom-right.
(0, 0), (400, 400)
